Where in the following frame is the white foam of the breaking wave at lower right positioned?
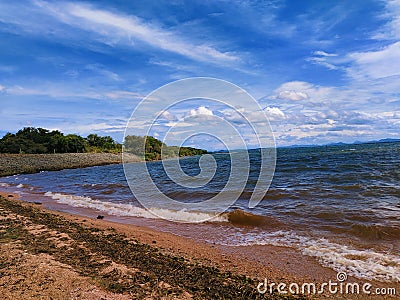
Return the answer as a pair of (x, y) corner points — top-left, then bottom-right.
(214, 231), (400, 282)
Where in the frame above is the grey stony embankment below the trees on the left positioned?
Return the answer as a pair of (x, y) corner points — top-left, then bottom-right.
(0, 153), (140, 177)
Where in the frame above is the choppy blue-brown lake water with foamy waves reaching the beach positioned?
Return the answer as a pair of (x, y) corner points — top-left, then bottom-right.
(0, 143), (400, 281)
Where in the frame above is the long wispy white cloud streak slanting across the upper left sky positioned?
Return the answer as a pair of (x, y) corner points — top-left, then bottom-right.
(35, 1), (239, 64)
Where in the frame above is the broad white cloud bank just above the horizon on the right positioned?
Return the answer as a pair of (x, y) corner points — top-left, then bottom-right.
(262, 78), (400, 145)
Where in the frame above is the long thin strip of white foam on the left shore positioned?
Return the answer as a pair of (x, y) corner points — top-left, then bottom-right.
(44, 192), (227, 223)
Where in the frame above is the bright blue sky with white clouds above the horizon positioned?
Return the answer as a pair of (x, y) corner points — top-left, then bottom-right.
(0, 0), (400, 149)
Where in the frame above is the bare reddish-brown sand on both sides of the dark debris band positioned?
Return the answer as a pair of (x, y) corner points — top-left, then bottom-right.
(0, 194), (400, 299)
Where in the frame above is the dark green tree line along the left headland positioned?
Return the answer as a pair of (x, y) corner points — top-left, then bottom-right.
(0, 127), (207, 161)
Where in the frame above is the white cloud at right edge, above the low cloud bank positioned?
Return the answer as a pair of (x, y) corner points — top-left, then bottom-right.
(348, 42), (400, 79)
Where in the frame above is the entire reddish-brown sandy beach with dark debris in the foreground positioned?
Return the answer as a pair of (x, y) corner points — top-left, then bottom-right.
(0, 193), (398, 299)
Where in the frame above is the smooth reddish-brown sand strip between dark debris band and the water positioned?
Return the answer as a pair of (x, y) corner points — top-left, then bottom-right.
(0, 193), (399, 299)
